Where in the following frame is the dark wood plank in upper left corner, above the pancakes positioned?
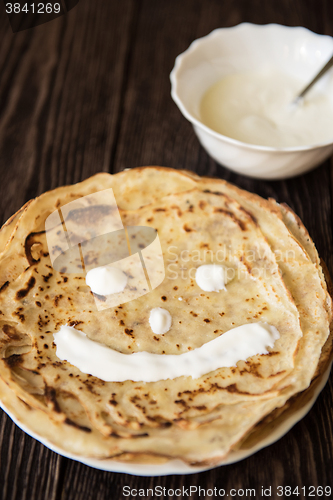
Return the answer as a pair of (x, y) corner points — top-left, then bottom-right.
(0, 0), (135, 225)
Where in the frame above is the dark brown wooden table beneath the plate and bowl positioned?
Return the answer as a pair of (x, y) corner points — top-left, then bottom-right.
(0, 0), (333, 500)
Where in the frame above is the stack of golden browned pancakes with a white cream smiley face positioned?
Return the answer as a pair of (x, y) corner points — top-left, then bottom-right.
(0, 167), (332, 464)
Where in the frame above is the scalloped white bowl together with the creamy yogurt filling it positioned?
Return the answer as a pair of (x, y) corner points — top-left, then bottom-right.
(171, 23), (333, 179)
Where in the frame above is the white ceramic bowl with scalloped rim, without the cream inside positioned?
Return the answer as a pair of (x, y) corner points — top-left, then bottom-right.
(170, 23), (333, 179)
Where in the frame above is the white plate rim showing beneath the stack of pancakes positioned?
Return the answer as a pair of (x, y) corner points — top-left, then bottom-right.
(0, 364), (331, 476)
